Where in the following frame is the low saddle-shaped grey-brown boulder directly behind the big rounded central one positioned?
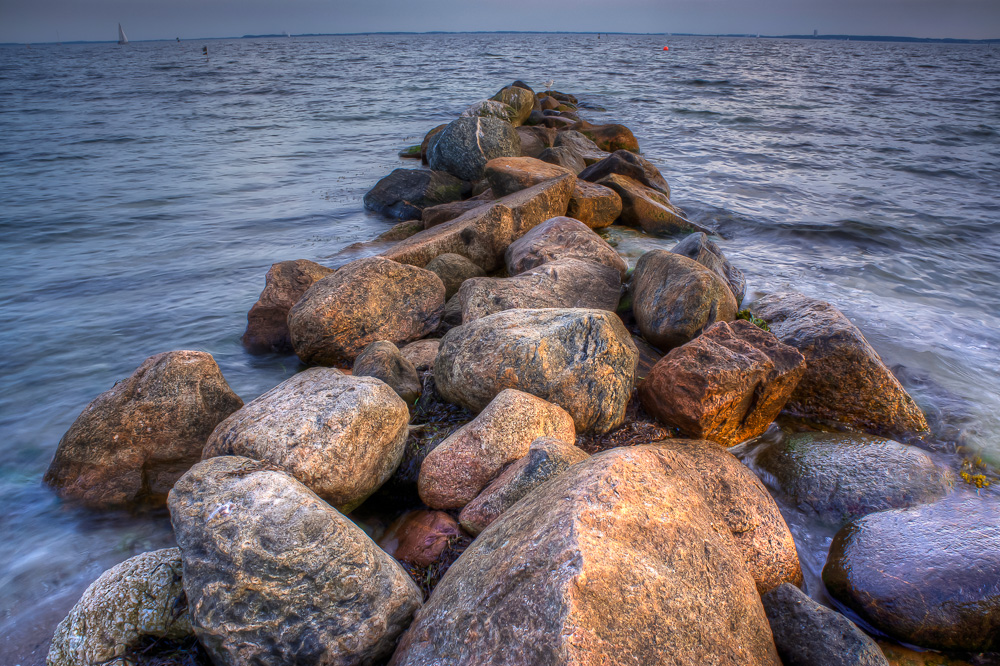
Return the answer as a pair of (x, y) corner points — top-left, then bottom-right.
(458, 258), (622, 324)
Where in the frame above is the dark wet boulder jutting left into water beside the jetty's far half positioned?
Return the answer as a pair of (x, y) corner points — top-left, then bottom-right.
(364, 169), (472, 220)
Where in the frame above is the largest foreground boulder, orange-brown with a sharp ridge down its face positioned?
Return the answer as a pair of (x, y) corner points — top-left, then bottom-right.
(390, 446), (781, 666)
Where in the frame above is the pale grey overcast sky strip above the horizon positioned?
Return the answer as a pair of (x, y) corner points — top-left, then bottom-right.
(0, 0), (1000, 42)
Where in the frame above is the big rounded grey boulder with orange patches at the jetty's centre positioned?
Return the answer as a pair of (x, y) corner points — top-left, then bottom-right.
(434, 309), (639, 434)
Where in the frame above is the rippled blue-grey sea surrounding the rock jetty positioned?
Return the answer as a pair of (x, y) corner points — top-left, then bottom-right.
(0, 35), (1000, 665)
